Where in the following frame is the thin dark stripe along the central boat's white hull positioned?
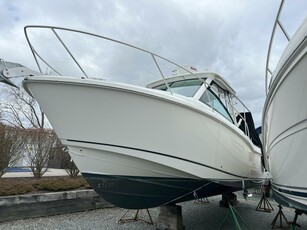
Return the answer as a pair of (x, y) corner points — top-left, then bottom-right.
(67, 139), (259, 179)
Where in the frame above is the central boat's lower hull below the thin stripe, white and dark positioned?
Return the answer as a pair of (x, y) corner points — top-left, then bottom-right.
(64, 140), (261, 209)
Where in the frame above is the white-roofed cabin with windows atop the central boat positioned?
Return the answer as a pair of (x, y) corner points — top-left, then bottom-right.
(147, 72), (262, 148)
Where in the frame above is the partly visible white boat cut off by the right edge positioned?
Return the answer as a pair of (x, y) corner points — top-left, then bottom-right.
(262, 0), (307, 212)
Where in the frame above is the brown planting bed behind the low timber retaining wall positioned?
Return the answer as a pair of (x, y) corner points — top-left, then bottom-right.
(0, 176), (89, 196)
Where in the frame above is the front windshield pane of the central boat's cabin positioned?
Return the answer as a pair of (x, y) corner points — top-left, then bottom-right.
(154, 79), (203, 97)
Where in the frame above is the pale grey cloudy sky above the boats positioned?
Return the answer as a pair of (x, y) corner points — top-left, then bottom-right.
(0, 0), (307, 125)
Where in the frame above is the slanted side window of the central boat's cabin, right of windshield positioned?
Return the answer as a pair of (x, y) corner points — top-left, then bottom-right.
(199, 89), (233, 123)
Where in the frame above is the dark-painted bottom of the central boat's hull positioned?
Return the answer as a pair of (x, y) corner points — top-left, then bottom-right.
(82, 173), (239, 209)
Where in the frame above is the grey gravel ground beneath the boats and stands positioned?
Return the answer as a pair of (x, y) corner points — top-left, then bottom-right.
(0, 194), (307, 230)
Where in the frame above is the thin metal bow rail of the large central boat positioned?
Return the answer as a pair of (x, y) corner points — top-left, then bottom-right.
(24, 25), (255, 138)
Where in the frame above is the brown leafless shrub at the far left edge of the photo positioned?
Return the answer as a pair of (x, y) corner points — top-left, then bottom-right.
(0, 123), (25, 177)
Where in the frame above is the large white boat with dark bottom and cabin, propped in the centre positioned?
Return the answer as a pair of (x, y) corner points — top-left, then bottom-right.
(5, 27), (266, 209)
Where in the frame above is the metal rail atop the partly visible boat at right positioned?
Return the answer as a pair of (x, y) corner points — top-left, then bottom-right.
(265, 0), (290, 94)
